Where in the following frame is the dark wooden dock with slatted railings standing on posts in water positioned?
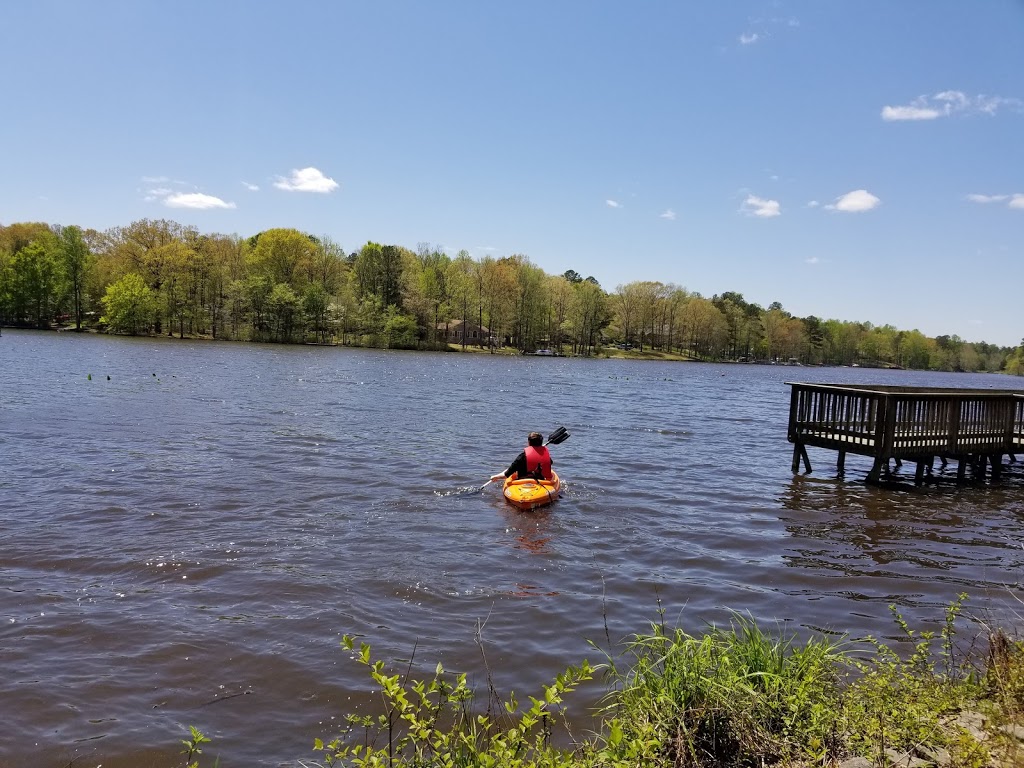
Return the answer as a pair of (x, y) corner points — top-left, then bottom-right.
(786, 382), (1024, 484)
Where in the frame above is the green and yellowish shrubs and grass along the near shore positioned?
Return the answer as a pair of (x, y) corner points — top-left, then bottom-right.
(184, 595), (1024, 768)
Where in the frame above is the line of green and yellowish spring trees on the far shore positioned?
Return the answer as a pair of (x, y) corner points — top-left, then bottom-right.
(0, 219), (1024, 374)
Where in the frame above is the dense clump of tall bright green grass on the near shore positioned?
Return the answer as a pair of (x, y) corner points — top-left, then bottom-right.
(604, 614), (843, 766)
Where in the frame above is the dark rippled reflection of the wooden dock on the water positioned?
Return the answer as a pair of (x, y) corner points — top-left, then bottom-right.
(779, 475), (1024, 605)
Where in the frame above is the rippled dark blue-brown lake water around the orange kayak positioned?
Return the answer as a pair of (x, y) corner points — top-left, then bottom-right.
(6, 330), (1024, 768)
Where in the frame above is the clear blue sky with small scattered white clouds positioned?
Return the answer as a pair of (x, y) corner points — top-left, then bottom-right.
(0, 0), (1024, 345)
